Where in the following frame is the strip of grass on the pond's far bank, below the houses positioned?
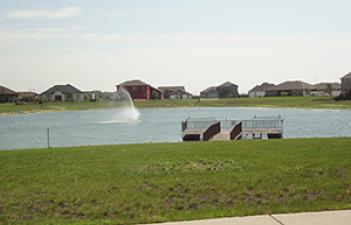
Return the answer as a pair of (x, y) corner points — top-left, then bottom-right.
(0, 97), (351, 114)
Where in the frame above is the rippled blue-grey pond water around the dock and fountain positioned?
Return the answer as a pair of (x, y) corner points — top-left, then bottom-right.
(0, 107), (351, 150)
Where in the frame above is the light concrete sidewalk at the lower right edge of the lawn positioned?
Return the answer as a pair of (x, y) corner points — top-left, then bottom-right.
(140, 210), (351, 225)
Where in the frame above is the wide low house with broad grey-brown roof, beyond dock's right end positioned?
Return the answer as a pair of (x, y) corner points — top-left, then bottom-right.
(266, 81), (314, 96)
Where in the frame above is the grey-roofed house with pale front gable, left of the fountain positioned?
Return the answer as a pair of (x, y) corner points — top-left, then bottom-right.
(40, 84), (84, 102)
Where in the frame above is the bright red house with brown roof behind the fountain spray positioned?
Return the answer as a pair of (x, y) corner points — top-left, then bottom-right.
(117, 80), (163, 100)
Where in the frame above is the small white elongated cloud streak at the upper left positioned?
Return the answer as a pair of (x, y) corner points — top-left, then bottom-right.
(7, 6), (82, 20)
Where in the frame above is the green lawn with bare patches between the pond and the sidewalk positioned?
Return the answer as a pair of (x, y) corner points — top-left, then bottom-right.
(0, 138), (351, 225)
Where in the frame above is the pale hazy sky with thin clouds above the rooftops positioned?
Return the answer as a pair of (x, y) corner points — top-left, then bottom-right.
(0, 0), (351, 94)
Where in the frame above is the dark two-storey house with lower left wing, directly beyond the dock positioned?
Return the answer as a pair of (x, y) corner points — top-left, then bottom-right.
(200, 82), (239, 98)
